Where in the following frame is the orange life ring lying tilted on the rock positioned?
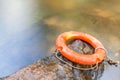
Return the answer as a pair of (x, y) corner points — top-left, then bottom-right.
(56, 31), (106, 65)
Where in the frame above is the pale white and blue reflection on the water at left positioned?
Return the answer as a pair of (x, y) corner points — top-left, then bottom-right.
(0, 0), (47, 77)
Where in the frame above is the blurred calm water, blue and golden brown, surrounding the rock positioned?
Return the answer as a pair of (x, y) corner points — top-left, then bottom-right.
(0, 0), (120, 80)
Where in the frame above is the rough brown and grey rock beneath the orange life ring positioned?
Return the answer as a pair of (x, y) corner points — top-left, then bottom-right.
(4, 40), (104, 80)
